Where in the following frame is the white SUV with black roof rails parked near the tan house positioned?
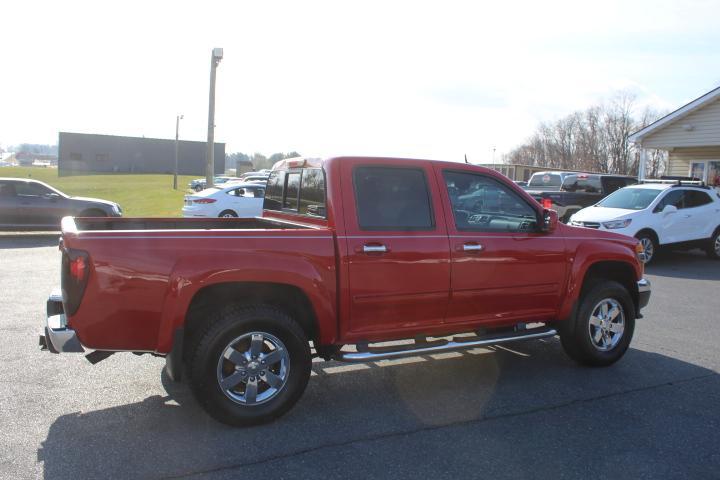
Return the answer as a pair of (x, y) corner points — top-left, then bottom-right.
(570, 183), (720, 263)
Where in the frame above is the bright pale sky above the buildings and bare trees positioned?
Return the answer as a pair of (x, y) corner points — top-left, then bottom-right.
(0, 0), (720, 162)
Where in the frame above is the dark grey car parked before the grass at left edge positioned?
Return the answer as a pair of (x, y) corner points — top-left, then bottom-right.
(0, 178), (122, 229)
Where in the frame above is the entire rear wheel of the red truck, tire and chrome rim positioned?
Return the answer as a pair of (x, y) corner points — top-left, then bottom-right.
(188, 305), (312, 426)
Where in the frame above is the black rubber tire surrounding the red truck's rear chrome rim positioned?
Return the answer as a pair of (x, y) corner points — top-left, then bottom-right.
(187, 305), (312, 427)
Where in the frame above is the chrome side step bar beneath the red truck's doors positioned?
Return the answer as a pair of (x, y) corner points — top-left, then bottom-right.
(333, 327), (557, 363)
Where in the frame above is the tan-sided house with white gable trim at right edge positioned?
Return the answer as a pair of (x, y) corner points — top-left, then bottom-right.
(628, 87), (720, 190)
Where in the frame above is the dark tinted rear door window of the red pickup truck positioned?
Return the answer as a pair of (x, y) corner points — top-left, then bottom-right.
(353, 167), (435, 230)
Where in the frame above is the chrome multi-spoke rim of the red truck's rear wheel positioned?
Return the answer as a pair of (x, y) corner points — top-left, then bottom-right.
(217, 332), (290, 405)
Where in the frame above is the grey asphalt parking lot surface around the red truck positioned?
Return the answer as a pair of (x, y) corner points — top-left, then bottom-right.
(0, 236), (720, 479)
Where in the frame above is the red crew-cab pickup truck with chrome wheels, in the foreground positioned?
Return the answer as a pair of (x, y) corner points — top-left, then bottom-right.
(40, 157), (650, 425)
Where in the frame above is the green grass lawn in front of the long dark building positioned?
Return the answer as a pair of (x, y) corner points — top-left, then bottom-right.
(0, 167), (199, 217)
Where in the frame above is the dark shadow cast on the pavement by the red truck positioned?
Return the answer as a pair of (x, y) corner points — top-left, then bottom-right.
(38, 339), (720, 479)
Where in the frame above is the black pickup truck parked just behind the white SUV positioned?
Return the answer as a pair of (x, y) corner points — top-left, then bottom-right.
(526, 173), (637, 223)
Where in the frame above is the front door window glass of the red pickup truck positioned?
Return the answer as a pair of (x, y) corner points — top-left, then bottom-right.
(443, 170), (537, 233)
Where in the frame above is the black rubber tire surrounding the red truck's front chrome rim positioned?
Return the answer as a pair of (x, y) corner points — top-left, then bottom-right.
(560, 280), (635, 367)
